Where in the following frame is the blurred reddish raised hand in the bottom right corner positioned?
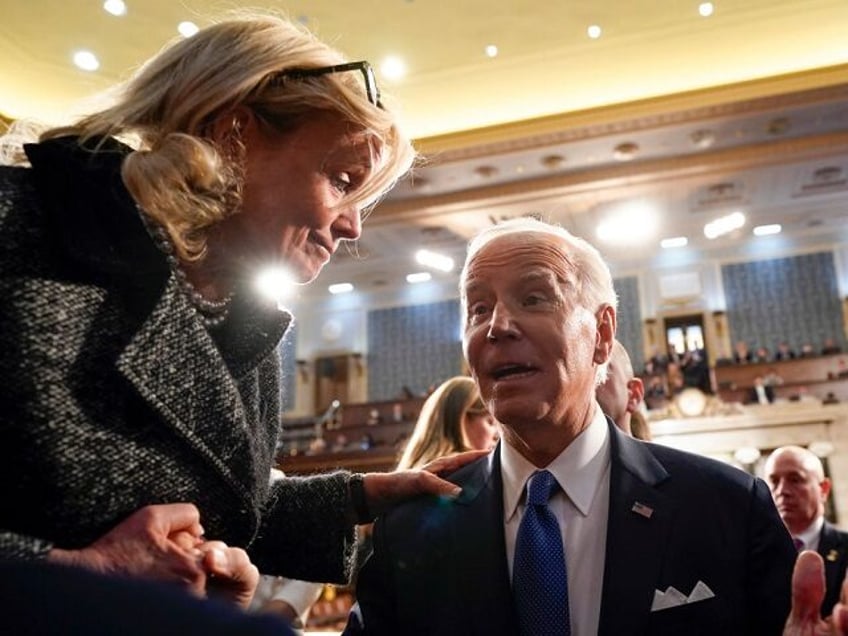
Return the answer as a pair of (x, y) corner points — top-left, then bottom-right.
(783, 550), (848, 636)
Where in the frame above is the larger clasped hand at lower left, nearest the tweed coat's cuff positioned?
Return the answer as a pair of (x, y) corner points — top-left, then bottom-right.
(47, 503), (206, 595)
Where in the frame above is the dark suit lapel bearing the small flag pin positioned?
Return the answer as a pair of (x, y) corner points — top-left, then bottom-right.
(599, 424), (675, 634)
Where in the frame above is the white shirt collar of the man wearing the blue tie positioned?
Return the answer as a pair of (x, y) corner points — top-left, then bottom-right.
(500, 403), (610, 521)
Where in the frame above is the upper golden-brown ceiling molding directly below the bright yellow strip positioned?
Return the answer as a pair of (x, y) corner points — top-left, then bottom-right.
(416, 64), (848, 163)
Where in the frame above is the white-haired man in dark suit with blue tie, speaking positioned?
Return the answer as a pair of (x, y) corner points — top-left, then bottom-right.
(347, 219), (795, 636)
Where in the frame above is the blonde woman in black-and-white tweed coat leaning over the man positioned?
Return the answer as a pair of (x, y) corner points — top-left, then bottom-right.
(0, 14), (476, 603)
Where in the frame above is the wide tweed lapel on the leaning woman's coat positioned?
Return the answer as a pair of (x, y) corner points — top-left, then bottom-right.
(118, 276), (254, 497)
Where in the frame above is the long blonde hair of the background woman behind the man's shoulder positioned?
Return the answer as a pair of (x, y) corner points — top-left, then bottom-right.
(397, 375), (486, 470)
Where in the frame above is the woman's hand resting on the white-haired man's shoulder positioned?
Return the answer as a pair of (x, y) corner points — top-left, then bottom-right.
(363, 450), (491, 516)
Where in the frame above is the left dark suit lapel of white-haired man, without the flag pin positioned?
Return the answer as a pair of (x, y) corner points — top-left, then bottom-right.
(451, 449), (518, 636)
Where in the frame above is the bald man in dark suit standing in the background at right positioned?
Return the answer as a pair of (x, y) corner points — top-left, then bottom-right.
(765, 446), (848, 616)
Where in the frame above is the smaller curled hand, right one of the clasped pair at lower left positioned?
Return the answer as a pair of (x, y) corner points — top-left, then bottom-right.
(198, 541), (259, 610)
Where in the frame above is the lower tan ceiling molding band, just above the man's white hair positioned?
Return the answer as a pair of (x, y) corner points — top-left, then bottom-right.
(368, 131), (848, 226)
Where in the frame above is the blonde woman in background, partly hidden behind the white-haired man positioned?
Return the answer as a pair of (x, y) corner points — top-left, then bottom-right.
(398, 376), (500, 469)
